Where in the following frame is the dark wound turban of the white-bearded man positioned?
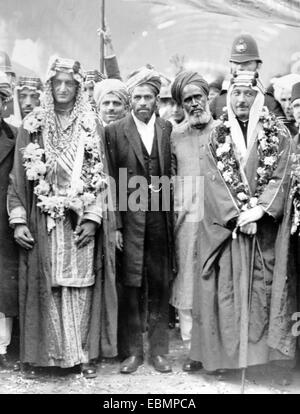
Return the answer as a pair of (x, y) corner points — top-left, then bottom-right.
(171, 70), (209, 105)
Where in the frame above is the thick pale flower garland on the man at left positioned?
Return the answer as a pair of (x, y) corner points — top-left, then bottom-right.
(22, 108), (107, 230)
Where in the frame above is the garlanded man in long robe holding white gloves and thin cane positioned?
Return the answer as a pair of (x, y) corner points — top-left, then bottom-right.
(190, 71), (293, 382)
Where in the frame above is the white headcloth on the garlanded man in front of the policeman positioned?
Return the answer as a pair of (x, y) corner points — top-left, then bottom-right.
(227, 71), (265, 167)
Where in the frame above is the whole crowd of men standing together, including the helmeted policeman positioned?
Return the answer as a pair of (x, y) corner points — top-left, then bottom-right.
(0, 30), (300, 386)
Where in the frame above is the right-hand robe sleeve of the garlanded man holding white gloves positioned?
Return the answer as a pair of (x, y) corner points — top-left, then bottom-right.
(257, 127), (292, 219)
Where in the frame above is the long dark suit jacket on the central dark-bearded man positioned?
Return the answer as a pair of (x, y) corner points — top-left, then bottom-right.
(105, 114), (176, 287)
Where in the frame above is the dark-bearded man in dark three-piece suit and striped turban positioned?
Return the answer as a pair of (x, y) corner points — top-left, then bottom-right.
(105, 68), (175, 374)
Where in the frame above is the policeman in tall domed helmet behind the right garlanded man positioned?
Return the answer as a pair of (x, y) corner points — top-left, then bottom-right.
(209, 33), (286, 122)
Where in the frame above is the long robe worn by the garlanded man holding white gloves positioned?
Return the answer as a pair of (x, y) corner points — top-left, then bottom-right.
(190, 118), (295, 370)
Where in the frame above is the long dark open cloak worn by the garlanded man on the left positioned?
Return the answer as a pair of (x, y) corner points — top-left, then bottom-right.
(8, 124), (117, 366)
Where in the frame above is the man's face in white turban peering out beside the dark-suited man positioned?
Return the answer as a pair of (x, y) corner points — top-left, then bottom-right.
(94, 79), (129, 126)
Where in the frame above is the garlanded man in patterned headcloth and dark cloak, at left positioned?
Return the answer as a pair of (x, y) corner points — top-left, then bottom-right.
(8, 57), (117, 378)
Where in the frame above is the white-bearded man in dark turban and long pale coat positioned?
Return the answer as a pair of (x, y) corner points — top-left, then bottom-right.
(171, 71), (217, 371)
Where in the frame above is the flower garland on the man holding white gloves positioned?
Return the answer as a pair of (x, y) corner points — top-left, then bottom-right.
(214, 107), (282, 211)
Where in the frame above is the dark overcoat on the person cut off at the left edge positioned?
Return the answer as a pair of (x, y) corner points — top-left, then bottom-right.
(0, 121), (18, 317)
